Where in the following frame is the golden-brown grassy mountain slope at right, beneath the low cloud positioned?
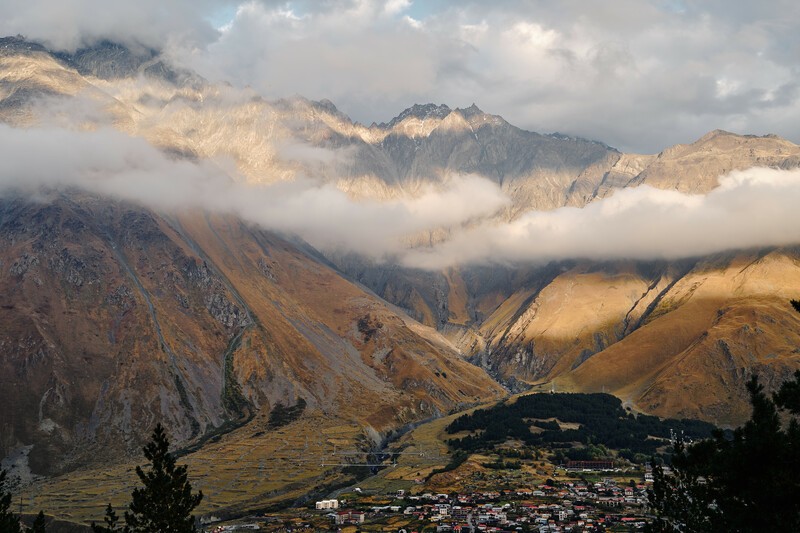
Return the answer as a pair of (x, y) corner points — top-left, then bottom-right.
(557, 251), (800, 425)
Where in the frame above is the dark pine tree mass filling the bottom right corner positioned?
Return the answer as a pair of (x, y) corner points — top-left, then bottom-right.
(648, 372), (800, 532)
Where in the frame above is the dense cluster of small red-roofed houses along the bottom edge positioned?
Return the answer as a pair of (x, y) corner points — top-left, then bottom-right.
(317, 478), (647, 533)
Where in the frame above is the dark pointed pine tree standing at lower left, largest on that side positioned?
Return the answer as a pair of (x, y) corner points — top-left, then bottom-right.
(123, 424), (203, 533)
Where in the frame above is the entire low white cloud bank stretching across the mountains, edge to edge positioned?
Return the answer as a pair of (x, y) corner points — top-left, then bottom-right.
(0, 125), (800, 269)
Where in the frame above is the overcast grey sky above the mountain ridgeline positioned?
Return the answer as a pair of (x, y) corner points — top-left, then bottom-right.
(0, 0), (800, 152)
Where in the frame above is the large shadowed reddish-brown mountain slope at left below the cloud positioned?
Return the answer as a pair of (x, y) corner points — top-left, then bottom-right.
(0, 193), (502, 473)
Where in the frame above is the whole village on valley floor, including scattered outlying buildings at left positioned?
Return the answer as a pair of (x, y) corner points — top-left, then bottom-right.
(205, 461), (653, 533)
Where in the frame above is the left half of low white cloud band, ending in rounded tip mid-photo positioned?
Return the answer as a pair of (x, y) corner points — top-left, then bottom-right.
(0, 124), (508, 259)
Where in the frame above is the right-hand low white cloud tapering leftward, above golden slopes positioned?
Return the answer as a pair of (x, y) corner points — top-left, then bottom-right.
(403, 168), (800, 269)
